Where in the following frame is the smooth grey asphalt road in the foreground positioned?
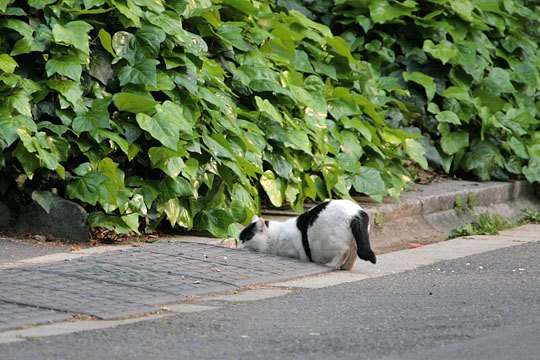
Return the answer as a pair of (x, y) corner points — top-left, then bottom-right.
(0, 243), (540, 360)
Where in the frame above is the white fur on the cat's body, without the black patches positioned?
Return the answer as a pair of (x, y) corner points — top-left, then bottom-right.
(238, 200), (374, 270)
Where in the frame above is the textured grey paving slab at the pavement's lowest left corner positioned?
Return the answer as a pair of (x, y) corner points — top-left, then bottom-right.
(0, 301), (71, 330)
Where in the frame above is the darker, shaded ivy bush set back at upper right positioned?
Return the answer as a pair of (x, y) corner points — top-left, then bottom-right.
(296, 0), (540, 182)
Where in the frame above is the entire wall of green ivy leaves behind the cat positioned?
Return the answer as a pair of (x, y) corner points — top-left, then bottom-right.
(0, 0), (540, 236)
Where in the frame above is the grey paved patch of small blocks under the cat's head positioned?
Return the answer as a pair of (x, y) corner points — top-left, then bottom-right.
(0, 241), (332, 330)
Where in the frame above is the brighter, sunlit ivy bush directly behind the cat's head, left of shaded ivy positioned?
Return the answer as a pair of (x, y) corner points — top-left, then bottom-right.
(0, 0), (422, 236)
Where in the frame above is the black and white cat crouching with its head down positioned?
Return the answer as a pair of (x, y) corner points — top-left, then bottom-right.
(238, 200), (377, 270)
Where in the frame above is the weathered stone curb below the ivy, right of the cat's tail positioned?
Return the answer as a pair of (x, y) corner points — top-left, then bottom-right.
(361, 180), (540, 252)
